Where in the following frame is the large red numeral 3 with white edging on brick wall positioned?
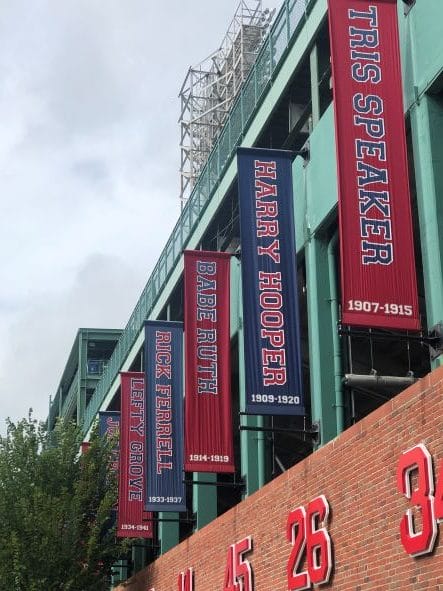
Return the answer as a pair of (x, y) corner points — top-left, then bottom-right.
(397, 443), (441, 556)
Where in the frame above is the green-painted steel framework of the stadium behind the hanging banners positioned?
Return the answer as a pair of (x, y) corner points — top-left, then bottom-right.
(50, 0), (443, 576)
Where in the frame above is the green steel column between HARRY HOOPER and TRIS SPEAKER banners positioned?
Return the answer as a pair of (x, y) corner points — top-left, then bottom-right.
(306, 236), (338, 445)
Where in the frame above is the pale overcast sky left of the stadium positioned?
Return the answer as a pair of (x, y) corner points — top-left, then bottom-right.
(0, 0), (281, 433)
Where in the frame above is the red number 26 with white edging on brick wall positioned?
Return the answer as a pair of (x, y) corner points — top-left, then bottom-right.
(286, 495), (332, 591)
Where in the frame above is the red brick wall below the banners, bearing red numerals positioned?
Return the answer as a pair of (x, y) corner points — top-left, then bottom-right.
(118, 368), (443, 591)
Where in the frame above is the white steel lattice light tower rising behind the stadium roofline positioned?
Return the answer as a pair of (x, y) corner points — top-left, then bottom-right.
(179, 0), (274, 207)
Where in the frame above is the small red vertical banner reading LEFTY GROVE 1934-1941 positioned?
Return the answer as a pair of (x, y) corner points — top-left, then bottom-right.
(117, 372), (153, 538)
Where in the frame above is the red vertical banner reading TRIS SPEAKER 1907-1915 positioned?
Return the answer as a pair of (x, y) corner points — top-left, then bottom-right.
(328, 0), (420, 330)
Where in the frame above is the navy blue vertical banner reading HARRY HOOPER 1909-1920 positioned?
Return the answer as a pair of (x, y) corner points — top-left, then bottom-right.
(237, 148), (305, 415)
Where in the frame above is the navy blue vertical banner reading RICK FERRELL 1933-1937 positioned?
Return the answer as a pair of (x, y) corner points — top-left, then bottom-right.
(145, 320), (186, 511)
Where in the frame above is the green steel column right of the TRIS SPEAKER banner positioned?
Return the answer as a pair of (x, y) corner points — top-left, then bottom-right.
(411, 95), (443, 366)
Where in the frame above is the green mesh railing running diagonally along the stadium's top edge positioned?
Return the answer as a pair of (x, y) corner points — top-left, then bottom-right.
(79, 0), (316, 432)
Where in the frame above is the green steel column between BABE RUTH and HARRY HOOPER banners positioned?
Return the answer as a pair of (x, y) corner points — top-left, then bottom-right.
(231, 258), (266, 496)
